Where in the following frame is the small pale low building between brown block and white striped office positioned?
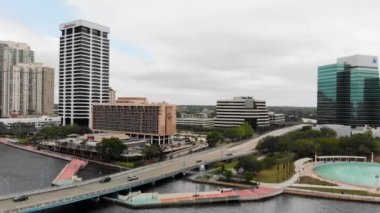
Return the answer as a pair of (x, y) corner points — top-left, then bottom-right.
(177, 113), (215, 128)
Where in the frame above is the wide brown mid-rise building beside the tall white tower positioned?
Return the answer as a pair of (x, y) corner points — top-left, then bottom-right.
(91, 98), (176, 145)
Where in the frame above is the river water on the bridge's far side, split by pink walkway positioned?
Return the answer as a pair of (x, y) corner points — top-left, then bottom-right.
(0, 144), (116, 195)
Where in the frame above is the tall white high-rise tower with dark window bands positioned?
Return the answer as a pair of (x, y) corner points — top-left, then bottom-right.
(59, 20), (110, 126)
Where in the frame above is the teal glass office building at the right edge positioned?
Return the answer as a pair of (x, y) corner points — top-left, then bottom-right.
(317, 55), (380, 127)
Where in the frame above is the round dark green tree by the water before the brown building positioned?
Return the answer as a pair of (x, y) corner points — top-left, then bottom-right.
(96, 137), (127, 160)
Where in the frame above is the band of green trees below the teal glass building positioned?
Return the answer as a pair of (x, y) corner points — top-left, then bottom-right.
(256, 127), (380, 158)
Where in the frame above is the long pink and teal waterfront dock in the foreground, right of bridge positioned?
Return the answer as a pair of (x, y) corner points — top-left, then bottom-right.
(103, 187), (283, 208)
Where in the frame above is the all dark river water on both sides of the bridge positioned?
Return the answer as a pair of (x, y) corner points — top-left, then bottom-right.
(0, 145), (380, 213)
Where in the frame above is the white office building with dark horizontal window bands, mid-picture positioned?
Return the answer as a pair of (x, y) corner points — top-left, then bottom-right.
(215, 97), (270, 129)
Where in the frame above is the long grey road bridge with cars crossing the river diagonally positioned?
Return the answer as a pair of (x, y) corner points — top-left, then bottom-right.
(0, 124), (305, 212)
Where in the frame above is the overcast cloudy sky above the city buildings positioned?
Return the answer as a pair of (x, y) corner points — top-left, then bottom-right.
(0, 0), (380, 106)
